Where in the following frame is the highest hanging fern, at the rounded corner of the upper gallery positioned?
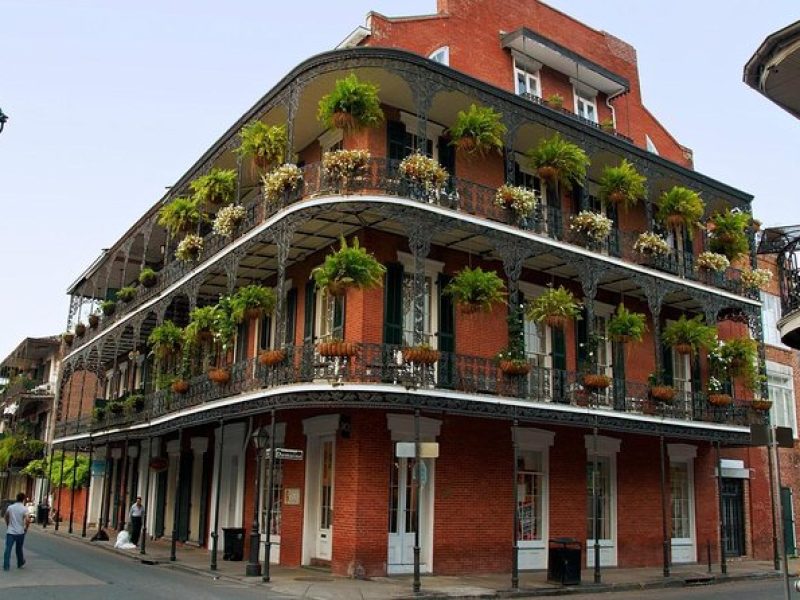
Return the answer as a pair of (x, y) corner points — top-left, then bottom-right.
(317, 73), (383, 131)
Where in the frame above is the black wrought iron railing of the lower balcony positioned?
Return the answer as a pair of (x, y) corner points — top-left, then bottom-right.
(56, 343), (763, 437)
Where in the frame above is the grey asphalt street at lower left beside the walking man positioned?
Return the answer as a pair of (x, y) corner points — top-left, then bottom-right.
(0, 526), (285, 600)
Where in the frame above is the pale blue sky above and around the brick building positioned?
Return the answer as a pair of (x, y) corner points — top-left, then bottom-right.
(0, 0), (800, 359)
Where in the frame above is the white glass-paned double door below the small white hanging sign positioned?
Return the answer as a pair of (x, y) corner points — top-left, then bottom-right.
(387, 458), (433, 574)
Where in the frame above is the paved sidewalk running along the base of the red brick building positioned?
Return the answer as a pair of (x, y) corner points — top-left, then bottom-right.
(36, 525), (780, 600)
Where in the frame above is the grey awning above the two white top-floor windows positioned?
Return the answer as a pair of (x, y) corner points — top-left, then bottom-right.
(500, 27), (630, 96)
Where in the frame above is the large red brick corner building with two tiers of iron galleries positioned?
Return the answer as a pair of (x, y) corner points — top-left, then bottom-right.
(55, 0), (796, 576)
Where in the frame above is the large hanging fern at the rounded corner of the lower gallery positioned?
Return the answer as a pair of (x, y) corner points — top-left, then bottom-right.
(311, 236), (386, 296)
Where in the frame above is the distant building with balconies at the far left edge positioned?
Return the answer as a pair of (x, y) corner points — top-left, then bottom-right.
(0, 337), (61, 503)
